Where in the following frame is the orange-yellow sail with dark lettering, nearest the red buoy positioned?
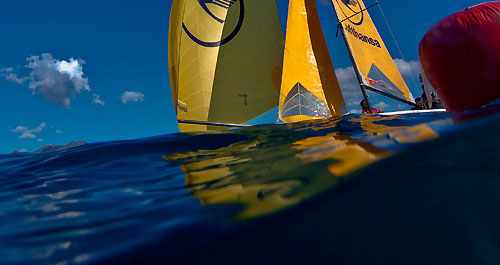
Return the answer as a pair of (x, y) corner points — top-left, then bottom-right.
(331, 0), (414, 102)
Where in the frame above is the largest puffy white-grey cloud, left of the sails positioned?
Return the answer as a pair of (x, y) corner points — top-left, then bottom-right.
(26, 53), (90, 108)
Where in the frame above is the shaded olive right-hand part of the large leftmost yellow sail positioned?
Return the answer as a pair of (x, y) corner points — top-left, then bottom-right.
(209, 0), (284, 129)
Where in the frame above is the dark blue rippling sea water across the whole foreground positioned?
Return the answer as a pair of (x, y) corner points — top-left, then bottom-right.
(0, 106), (500, 265)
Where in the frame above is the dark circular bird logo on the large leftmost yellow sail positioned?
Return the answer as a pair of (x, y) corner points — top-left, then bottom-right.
(182, 0), (245, 47)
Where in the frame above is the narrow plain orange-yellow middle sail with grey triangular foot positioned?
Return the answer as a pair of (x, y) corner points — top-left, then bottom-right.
(280, 0), (347, 122)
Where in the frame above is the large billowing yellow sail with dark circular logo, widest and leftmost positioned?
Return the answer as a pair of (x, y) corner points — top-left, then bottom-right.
(168, 0), (284, 131)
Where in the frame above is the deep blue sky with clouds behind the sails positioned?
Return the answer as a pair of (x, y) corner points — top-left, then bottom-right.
(0, 0), (481, 153)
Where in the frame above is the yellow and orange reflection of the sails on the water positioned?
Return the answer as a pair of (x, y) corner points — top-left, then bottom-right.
(164, 115), (444, 220)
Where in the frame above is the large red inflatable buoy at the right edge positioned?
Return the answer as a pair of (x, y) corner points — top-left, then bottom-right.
(418, 1), (500, 112)
